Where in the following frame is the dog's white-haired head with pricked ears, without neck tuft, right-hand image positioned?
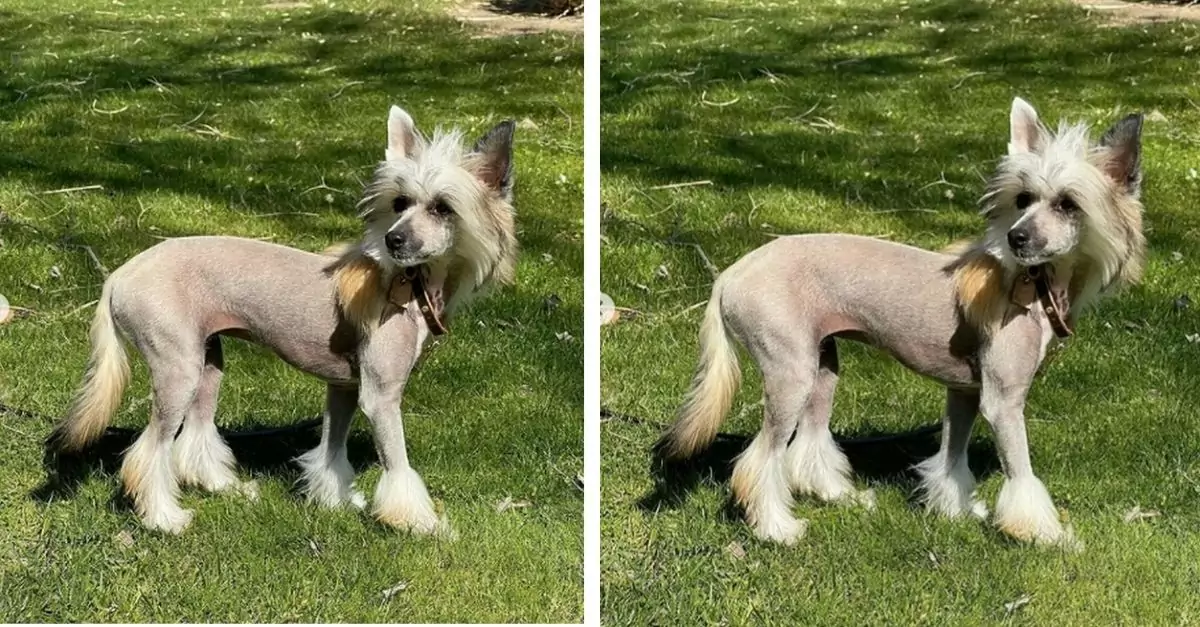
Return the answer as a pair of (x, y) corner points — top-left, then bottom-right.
(983, 98), (1142, 283)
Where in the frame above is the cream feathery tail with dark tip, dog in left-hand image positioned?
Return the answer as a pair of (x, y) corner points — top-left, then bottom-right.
(46, 277), (130, 452)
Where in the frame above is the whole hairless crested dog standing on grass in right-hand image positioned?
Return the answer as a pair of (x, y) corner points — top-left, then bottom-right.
(658, 98), (1146, 548)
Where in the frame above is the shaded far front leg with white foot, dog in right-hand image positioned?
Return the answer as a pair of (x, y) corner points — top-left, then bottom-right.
(917, 389), (988, 519)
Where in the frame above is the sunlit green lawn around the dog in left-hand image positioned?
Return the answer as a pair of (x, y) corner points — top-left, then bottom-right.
(0, 0), (583, 622)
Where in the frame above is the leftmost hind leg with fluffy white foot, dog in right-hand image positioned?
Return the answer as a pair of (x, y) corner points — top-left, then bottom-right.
(731, 341), (817, 544)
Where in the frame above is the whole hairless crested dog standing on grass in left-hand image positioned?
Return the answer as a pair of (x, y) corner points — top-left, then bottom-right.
(47, 107), (517, 533)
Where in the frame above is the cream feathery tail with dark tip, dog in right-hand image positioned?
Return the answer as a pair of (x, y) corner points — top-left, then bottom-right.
(658, 277), (742, 459)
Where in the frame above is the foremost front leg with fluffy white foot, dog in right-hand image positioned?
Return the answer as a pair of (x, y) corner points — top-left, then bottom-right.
(980, 364), (1082, 550)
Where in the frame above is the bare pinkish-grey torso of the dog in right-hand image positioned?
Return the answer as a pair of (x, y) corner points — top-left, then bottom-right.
(721, 234), (988, 388)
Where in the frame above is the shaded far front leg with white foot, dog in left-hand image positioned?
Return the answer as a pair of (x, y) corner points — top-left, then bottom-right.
(296, 384), (367, 509)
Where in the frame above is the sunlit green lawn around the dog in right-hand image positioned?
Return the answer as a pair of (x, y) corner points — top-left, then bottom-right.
(601, 0), (1200, 625)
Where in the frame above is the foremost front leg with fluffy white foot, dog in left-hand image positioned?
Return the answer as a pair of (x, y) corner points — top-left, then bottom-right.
(359, 368), (450, 535)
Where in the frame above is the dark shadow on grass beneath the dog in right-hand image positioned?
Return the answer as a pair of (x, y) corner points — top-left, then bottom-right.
(637, 428), (1000, 519)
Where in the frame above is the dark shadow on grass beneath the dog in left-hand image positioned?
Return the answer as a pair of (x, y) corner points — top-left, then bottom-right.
(29, 420), (377, 509)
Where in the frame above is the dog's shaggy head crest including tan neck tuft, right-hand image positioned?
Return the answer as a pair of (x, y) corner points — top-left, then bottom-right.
(949, 98), (1146, 329)
